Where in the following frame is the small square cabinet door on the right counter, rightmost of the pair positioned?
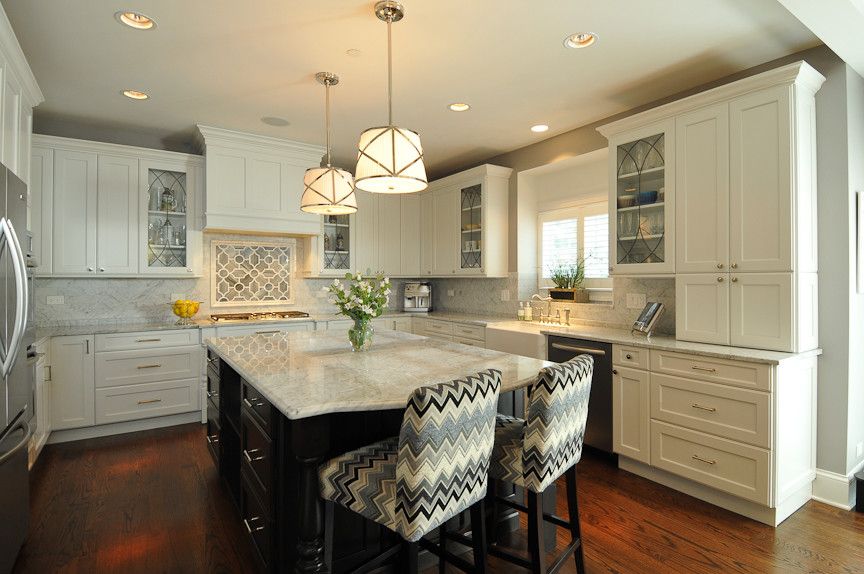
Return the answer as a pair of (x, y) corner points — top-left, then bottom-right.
(730, 273), (795, 352)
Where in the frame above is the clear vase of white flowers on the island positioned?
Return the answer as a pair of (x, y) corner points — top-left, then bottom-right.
(324, 273), (390, 351)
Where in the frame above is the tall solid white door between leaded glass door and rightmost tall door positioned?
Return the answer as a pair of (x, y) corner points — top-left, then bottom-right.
(675, 102), (729, 273)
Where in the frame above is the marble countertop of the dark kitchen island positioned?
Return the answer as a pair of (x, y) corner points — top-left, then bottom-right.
(207, 331), (550, 419)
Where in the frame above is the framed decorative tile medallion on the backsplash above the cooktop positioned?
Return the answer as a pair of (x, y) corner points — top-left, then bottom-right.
(210, 239), (296, 307)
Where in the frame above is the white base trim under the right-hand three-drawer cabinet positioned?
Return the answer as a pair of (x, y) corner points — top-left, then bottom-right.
(618, 456), (812, 526)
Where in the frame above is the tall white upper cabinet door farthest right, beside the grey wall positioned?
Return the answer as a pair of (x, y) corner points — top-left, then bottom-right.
(729, 87), (792, 272)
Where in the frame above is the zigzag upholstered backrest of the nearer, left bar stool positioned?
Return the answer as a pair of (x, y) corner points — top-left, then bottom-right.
(395, 369), (501, 542)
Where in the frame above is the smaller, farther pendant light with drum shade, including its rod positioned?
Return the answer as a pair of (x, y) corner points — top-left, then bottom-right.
(300, 72), (357, 215)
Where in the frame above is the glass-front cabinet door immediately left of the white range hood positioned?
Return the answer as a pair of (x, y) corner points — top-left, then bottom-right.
(140, 156), (201, 275)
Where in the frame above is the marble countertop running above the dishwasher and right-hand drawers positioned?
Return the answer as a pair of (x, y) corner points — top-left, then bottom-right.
(487, 321), (822, 365)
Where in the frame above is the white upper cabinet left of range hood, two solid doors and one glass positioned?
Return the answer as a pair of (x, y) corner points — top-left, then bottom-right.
(30, 135), (204, 277)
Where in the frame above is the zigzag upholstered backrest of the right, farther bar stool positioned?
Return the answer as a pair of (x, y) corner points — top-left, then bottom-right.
(522, 355), (594, 492)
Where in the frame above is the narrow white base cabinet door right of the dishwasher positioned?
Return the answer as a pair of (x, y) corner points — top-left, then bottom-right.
(612, 366), (651, 464)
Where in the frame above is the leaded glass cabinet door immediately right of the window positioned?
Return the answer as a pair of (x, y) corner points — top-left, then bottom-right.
(609, 123), (675, 275)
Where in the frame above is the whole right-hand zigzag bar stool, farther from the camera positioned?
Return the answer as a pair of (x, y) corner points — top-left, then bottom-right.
(489, 355), (594, 574)
